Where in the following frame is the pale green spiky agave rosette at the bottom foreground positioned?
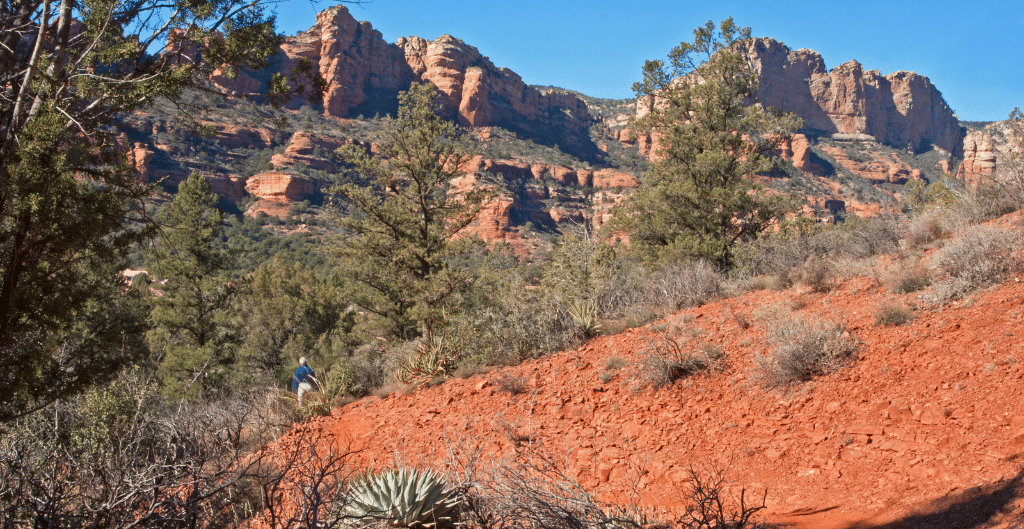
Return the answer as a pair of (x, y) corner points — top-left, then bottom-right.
(347, 469), (459, 529)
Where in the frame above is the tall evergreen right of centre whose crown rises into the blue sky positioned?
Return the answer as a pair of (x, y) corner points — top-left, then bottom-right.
(616, 18), (801, 268)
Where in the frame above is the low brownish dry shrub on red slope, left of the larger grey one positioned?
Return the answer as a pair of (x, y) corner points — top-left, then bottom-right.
(640, 333), (725, 388)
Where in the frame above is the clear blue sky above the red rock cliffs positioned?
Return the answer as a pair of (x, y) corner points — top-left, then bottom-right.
(279, 0), (1024, 121)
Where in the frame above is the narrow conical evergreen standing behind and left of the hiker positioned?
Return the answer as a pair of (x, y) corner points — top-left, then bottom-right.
(146, 173), (234, 397)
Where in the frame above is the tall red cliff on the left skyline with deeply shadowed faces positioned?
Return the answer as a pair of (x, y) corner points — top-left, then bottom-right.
(223, 5), (601, 160)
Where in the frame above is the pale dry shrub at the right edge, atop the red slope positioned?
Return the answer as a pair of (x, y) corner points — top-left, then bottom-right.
(935, 226), (1024, 303)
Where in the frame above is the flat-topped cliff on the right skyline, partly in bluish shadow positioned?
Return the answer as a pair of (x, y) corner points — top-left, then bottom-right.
(746, 38), (963, 155)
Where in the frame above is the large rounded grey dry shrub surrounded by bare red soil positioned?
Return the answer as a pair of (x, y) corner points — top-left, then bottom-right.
(755, 315), (857, 387)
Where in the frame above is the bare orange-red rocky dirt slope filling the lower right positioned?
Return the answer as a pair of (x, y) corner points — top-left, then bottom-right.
(268, 212), (1024, 529)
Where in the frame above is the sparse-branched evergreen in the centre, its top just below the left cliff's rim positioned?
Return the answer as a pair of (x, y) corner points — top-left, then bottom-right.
(327, 84), (488, 339)
